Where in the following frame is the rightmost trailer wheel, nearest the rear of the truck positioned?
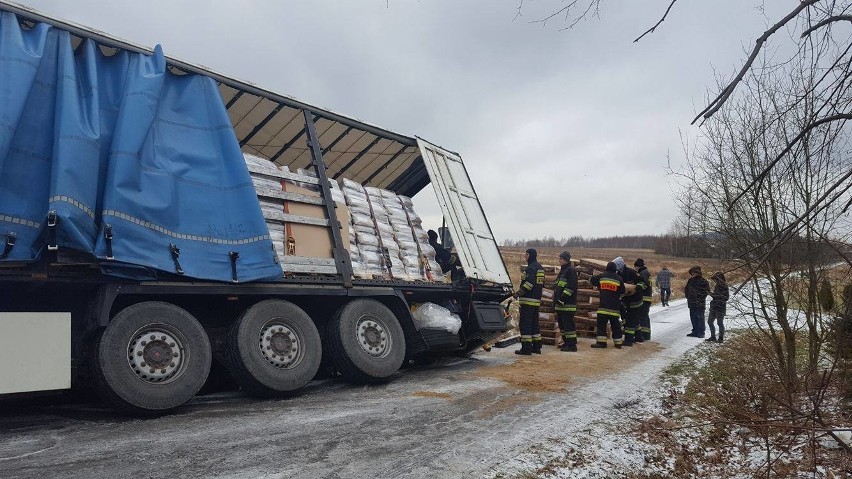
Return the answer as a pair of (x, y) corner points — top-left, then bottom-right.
(328, 299), (405, 383)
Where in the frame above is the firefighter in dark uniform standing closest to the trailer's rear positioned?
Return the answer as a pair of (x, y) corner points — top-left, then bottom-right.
(515, 248), (544, 356)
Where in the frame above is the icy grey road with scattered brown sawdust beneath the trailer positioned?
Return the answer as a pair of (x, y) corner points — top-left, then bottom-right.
(0, 300), (701, 479)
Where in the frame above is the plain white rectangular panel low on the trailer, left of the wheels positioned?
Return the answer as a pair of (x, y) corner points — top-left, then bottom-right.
(0, 313), (71, 394)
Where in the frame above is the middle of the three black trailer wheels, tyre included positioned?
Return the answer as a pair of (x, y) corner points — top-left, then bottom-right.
(226, 300), (322, 396)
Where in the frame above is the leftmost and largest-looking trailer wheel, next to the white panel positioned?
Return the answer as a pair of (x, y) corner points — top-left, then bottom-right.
(92, 301), (212, 415)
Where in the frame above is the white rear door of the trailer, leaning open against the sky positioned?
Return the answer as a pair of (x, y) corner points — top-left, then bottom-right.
(417, 138), (512, 284)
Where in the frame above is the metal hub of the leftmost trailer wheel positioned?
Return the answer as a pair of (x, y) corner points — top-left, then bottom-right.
(127, 328), (183, 383)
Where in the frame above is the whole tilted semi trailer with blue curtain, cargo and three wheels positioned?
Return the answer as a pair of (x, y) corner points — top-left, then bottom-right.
(0, 1), (512, 414)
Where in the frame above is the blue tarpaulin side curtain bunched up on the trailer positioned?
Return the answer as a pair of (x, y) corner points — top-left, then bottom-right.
(0, 12), (282, 282)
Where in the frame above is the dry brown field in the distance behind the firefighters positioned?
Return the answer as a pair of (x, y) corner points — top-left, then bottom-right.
(500, 246), (736, 302)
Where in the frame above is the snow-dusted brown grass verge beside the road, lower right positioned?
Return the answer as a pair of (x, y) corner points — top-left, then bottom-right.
(631, 330), (852, 478)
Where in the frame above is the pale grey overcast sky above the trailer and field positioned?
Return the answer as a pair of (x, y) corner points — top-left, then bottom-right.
(11, 0), (784, 241)
